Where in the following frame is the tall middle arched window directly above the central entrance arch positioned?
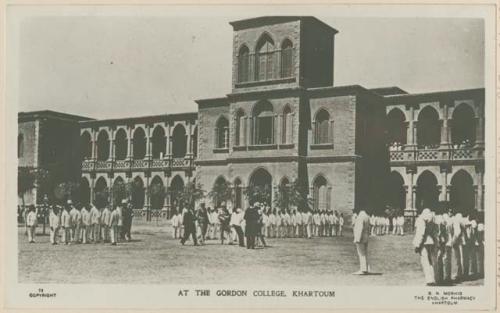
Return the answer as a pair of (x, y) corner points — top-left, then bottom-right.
(252, 101), (274, 145)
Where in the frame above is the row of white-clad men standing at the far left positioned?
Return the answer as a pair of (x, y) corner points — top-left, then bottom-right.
(26, 200), (133, 245)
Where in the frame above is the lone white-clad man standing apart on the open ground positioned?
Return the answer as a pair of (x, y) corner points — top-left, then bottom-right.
(353, 209), (370, 275)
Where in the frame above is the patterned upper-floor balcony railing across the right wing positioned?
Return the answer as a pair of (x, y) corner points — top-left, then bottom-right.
(389, 147), (484, 162)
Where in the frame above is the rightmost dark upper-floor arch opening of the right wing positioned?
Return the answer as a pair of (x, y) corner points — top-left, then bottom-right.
(451, 103), (476, 146)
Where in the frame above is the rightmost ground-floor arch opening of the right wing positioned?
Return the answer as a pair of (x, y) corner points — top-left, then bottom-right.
(450, 169), (475, 214)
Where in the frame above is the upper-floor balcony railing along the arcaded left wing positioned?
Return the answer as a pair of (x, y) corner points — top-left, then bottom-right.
(82, 157), (194, 172)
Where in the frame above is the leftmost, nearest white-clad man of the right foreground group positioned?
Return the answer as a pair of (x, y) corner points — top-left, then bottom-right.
(413, 209), (437, 286)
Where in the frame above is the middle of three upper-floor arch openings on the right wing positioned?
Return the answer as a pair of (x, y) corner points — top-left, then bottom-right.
(417, 106), (441, 148)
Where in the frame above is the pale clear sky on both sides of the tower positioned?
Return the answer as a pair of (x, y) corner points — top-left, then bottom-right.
(13, 10), (484, 119)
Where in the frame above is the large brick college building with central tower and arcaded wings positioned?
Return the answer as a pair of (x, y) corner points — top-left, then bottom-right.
(20, 16), (484, 219)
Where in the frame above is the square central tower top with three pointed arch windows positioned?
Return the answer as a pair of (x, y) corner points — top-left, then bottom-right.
(230, 16), (337, 93)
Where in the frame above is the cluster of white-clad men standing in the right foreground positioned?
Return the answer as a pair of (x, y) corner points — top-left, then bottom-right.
(413, 209), (484, 286)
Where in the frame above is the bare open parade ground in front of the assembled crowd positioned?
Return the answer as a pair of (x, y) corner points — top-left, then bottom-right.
(18, 221), (483, 286)
